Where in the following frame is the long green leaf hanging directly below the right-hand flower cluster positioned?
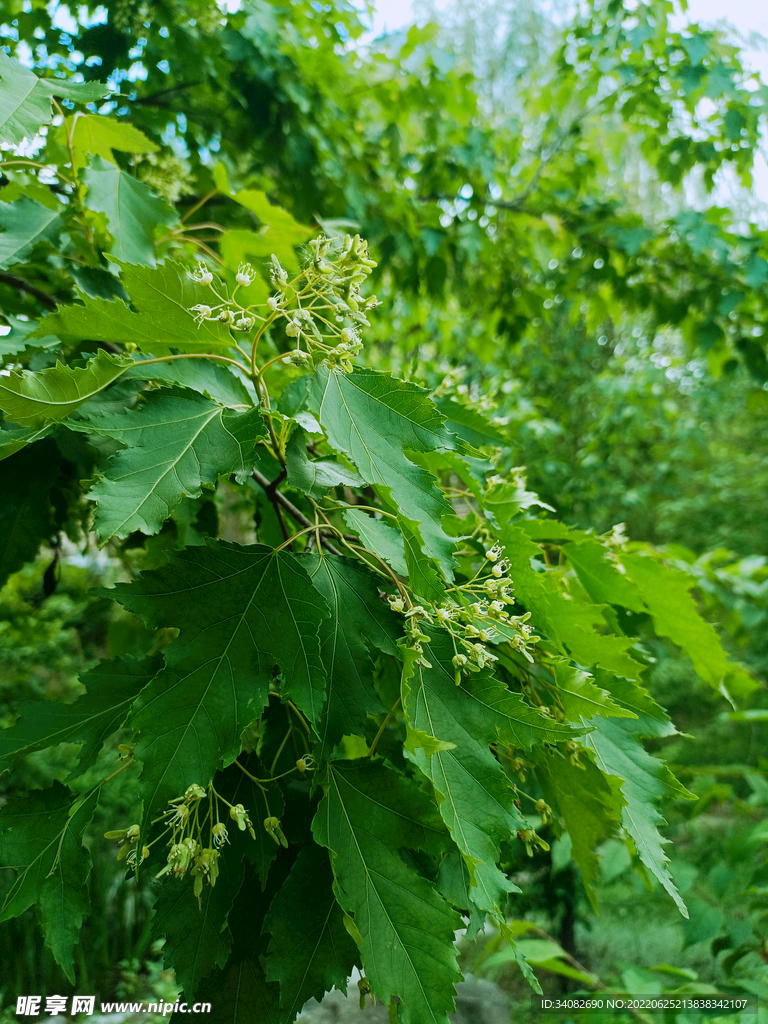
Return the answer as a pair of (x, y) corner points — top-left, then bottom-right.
(402, 631), (526, 916)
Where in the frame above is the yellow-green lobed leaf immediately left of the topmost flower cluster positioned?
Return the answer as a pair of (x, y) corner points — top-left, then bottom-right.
(31, 260), (232, 356)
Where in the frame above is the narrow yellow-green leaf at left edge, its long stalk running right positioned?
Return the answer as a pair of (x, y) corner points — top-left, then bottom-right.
(0, 349), (131, 427)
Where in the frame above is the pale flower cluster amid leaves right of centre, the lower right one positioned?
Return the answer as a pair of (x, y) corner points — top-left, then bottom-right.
(388, 545), (539, 686)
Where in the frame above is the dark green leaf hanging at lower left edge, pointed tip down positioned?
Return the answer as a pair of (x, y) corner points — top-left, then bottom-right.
(0, 782), (98, 985)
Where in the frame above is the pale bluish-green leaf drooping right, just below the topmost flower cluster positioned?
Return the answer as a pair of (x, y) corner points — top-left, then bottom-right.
(306, 365), (472, 578)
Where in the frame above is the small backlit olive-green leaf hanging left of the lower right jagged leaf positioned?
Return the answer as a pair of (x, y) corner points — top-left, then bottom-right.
(530, 746), (625, 910)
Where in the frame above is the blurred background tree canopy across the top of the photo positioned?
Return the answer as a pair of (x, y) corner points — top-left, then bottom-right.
(4, 0), (768, 382)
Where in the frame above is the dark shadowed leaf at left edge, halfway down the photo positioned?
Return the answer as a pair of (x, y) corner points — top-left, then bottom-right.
(0, 431), (61, 587)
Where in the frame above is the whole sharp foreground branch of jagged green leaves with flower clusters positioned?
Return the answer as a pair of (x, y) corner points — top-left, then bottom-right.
(0, 49), (757, 1024)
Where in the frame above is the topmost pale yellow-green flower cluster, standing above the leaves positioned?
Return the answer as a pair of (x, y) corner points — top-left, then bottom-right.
(189, 234), (379, 373)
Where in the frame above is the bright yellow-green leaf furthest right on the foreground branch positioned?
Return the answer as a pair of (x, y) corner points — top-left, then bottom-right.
(622, 555), (758, 692)
